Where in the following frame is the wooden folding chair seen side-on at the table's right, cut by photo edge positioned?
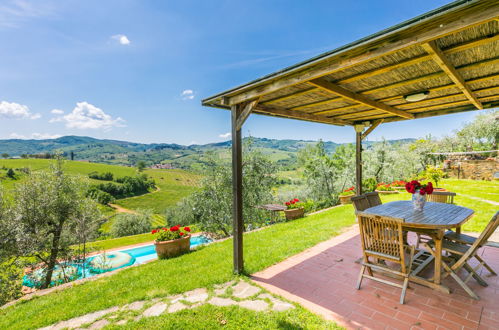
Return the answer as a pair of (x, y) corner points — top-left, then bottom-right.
(424, 211), (499, 300)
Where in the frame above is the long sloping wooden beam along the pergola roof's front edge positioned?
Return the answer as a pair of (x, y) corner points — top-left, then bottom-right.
(218, 6), (499, 104)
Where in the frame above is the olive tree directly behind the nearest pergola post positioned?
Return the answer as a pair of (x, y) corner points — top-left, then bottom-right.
(166, 148), (276, 237)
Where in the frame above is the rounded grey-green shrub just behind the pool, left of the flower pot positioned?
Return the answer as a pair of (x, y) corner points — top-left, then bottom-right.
(111, 210), (152, 237)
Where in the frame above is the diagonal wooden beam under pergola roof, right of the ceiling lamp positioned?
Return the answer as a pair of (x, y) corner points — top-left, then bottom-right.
(422, 41), (483, 109)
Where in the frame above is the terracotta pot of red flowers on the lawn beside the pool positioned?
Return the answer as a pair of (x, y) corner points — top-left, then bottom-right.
(151, 225), (191, 259)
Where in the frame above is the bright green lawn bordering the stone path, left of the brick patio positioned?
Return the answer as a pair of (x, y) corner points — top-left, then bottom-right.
(0, 205), (355, 329)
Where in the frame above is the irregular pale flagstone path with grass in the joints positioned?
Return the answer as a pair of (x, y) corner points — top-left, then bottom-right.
(41, 280), (295, 330)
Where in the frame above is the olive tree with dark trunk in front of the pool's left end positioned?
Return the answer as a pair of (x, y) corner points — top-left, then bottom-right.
(11, 160), (101, 288)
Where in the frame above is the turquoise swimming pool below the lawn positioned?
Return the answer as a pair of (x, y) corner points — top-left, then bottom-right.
(23, 235), (211, 287)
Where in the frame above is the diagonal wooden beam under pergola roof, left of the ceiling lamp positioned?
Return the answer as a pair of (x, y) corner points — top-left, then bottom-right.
(309, 78), (414, 119)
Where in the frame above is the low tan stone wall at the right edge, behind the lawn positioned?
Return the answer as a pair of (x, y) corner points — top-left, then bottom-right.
(445, 158), (499, 180)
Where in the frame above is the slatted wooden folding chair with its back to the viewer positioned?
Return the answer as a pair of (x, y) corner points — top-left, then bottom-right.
(357, 214), (414, 304)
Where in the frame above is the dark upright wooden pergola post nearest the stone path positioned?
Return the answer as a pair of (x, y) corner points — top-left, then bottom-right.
(231, 105), (244, 274)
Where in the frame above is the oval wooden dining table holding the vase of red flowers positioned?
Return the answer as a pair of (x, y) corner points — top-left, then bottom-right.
(357, 201), (475, 293)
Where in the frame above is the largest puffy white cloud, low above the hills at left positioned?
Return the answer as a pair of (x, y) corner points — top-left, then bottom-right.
(50, 102), (126, 130)
